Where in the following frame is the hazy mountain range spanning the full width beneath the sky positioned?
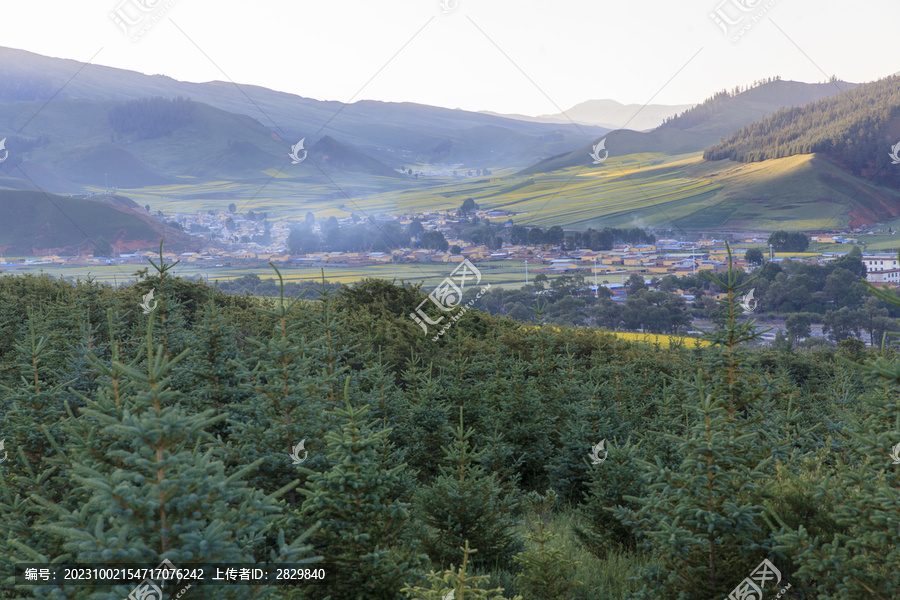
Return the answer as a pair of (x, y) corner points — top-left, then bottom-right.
(0, 48), (900, 251)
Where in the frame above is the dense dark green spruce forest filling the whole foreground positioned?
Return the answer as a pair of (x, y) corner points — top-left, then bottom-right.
(0, 245), (900, 600)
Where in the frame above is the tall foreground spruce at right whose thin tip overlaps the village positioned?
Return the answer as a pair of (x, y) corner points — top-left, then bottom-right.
(614, 250), (772, 600)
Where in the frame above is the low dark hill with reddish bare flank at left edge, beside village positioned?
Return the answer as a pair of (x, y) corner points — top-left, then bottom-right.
(0, 189), (197, 256)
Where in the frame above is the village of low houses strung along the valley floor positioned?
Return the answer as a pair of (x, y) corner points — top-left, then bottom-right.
(7, 204), (900, 298)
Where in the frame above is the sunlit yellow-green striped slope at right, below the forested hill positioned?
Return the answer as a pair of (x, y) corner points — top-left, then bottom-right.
(359, 153), (900, 231)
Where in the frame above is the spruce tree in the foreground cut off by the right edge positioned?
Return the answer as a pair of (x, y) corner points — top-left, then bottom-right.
(771, 278), (900, 600)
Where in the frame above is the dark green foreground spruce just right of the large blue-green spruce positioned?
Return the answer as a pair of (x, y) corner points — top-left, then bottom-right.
(300, 377), (424, 600)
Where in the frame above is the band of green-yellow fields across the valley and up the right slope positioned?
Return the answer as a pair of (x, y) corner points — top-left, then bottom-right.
(109, 153), (896, 232)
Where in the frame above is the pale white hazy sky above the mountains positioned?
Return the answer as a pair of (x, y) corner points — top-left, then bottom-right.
(0, 0), (900, 115)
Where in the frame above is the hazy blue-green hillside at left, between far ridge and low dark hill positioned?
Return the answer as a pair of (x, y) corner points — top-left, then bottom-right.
(0, 98), (408, 193)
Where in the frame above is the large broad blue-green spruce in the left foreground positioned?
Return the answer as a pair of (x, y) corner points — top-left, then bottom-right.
(11, 314), (310, 600)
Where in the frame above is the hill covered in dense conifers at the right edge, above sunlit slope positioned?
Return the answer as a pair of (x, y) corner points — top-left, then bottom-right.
(703, 75), (900, 184)
